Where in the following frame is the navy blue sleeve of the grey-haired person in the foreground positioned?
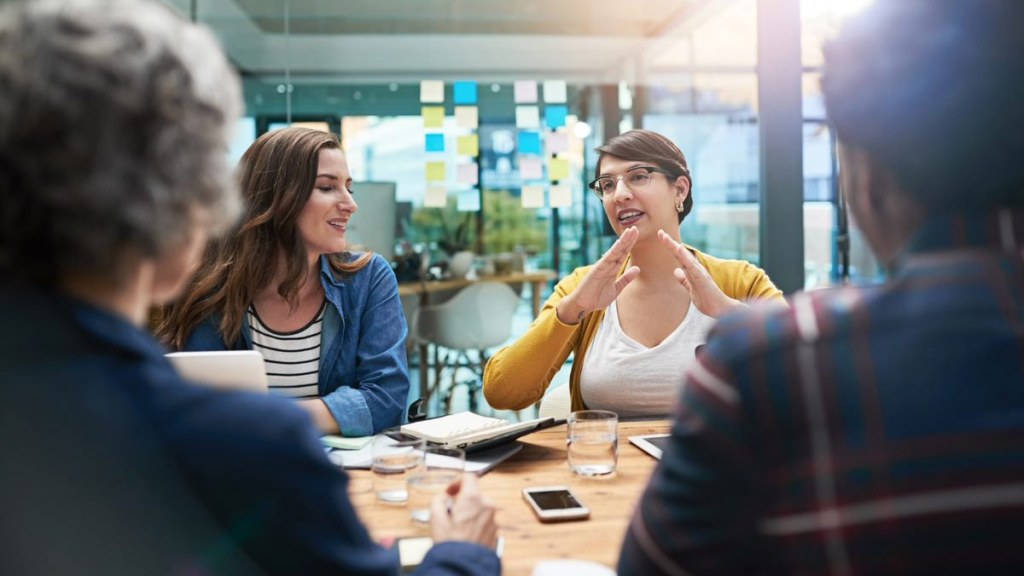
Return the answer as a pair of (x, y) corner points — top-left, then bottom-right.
(160, 385), (398, 576)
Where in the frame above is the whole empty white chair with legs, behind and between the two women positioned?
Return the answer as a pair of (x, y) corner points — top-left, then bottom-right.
(413, 282), (519, 413)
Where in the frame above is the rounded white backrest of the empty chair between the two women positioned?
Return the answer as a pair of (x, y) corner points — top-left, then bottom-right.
(413, 282), (519, 349)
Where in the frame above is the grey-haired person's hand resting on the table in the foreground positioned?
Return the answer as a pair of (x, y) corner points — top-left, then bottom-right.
(430, 474), (498, 548)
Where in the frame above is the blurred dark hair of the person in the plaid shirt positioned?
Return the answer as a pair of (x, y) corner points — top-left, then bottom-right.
(821, 0), (1024, 211)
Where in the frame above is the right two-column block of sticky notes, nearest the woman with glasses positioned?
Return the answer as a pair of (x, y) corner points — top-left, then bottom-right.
(512, 80), (572, 208)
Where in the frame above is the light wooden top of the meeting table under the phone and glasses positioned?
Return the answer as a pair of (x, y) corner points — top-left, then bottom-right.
(349, 420), (669, 576)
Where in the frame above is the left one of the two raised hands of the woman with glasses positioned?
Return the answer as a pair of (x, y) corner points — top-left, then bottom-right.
(555, 227), (640, 324)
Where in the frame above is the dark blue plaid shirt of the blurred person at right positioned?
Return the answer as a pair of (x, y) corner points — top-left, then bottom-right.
(618, 210), (1024, 576)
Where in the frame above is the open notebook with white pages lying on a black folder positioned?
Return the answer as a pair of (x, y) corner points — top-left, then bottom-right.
(401, 412), (557, 449)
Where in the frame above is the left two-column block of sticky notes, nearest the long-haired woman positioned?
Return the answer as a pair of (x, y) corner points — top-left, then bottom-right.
(420, 80), (480, 211)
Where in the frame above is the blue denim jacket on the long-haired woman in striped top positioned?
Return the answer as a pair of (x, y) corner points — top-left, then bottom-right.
(182, 254), (410, 437)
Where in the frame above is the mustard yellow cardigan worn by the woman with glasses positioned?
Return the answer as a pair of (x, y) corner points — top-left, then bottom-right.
(483, 247), (782, 410)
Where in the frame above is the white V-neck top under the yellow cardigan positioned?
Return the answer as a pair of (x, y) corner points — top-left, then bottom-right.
(580, 302), (715, 418)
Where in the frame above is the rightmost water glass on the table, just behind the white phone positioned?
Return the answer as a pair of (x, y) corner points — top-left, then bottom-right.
(566, 410), (618, 477)
